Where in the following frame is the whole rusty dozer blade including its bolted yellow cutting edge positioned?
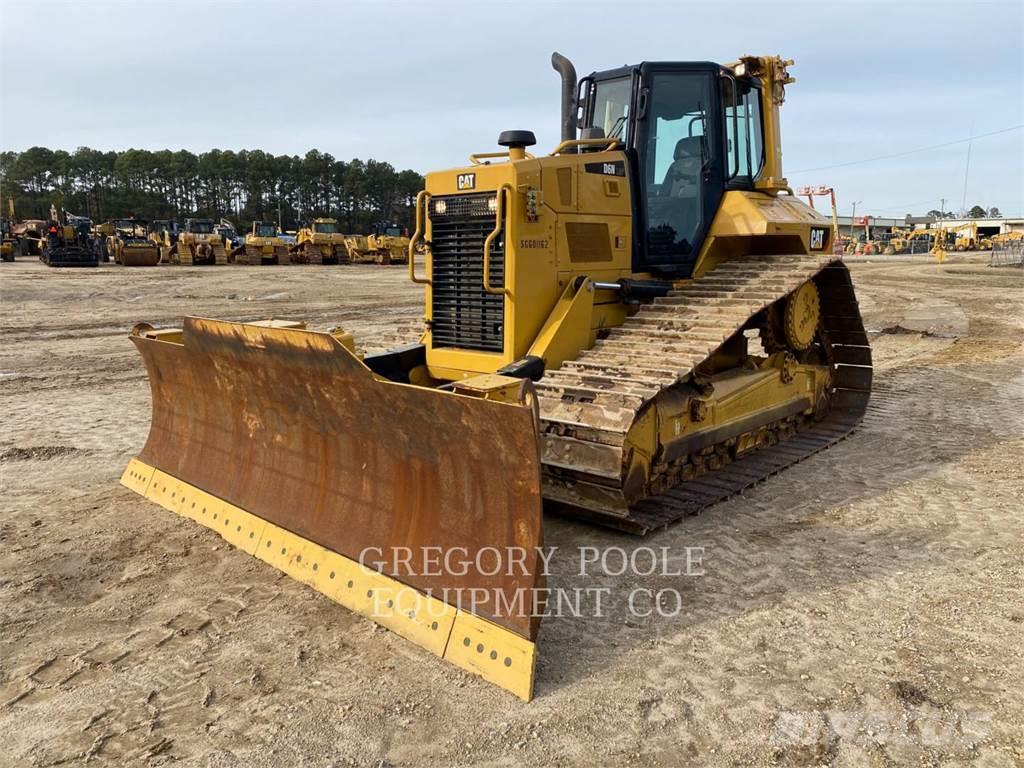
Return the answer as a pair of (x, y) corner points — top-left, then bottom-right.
(122, 318), (544, 699)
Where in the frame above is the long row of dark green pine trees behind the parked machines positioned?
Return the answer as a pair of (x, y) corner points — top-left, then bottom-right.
(0, 146), (424, 232)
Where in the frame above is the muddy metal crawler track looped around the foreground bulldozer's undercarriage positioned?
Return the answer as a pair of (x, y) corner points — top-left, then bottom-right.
(538, 255), (871, 534)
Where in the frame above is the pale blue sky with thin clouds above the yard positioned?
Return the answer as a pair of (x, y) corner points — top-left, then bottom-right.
(0, 0), (1024, 216)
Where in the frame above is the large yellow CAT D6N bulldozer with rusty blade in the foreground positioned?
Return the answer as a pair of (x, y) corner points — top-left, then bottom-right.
(122, 53), (871, 700)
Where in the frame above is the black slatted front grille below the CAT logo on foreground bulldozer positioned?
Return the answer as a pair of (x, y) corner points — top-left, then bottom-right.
(430, 193), (505, 352)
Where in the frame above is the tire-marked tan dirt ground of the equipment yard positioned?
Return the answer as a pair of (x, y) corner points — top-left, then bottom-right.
(0, 256), (1024, 767)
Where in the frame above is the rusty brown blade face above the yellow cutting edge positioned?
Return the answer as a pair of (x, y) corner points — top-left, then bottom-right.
(132, 317), (544, 640)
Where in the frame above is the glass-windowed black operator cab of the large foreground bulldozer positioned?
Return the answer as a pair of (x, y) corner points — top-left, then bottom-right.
(577, 61), (764, 278)
